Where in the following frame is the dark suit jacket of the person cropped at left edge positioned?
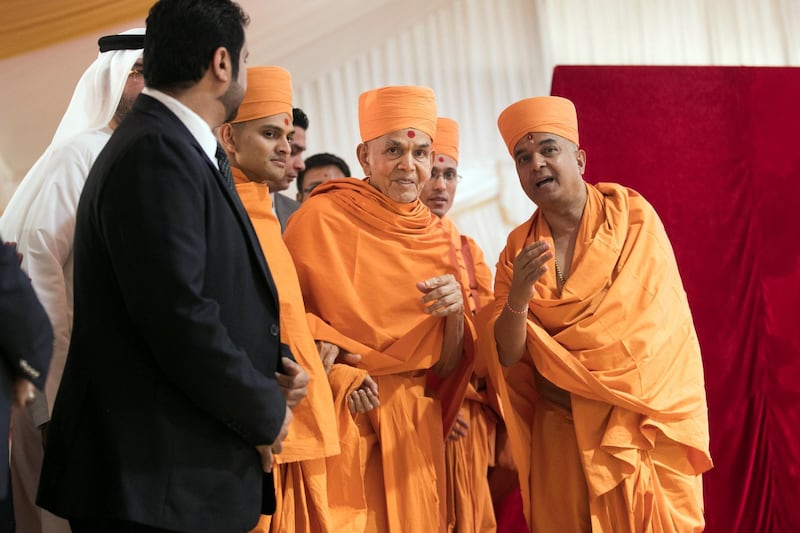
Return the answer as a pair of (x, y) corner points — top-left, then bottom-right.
(0, 238), (53, 500)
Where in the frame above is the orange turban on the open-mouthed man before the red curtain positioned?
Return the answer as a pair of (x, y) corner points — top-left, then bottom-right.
(497, 96), (579, 156)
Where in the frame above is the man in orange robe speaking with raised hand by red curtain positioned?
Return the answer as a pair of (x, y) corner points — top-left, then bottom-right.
(481, 97), (712, 533)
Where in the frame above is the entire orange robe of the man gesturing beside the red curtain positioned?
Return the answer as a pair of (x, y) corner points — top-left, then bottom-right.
(479, 184), (712, 532)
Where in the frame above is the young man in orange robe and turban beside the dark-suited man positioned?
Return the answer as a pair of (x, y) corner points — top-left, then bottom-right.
(218, 67), (377, 533)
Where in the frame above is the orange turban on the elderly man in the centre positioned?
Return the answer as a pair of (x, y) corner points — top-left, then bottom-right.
(358, 85), (436, 142)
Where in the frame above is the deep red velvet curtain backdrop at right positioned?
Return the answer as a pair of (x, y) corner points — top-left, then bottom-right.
(552, 66), (800, 533)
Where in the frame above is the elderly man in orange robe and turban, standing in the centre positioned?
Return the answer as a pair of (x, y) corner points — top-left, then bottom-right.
(284, 86), (473, 533)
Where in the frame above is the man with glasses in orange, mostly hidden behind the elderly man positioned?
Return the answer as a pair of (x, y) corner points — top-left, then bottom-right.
(419, 117), (497, 533)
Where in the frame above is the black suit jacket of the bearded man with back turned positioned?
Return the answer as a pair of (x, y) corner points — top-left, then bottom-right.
(38, 95), (286, 533)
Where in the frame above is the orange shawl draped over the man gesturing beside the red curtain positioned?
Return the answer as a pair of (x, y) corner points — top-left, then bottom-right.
(480, 184), (712, 523)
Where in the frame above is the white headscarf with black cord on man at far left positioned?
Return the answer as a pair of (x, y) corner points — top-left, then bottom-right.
(0, 28), (145, 240)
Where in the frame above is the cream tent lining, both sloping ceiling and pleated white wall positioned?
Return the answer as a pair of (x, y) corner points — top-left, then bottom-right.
(0, 0), (800, 266)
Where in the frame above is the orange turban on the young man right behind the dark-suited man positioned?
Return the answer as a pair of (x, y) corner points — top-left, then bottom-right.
(233, 67), (292, 123)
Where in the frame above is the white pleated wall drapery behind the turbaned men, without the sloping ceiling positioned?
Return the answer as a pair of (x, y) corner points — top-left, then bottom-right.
(286, 0), (800, 267)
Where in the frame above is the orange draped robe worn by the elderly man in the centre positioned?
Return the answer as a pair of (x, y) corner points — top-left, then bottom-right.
(284, 178), (474, 531)
